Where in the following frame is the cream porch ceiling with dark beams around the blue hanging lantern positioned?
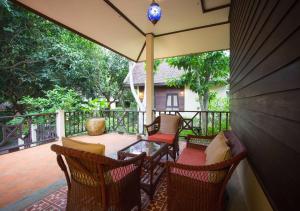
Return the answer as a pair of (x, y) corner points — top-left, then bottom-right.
(15, 0), (230, 62)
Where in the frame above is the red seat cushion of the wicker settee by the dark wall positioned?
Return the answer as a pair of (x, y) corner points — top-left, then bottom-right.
(177, 147), (206, 166)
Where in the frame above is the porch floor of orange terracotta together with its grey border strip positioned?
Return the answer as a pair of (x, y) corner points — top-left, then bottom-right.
(0, 133), (247, 211)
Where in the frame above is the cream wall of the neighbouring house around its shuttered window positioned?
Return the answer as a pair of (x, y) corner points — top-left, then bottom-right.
(154, 87), (184, 111)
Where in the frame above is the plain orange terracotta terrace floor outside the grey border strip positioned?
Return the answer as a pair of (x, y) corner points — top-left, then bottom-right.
(0, 134), (136, 208)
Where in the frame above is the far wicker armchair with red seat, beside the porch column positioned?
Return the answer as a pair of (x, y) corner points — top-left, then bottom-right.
(145, 115), (182, 160)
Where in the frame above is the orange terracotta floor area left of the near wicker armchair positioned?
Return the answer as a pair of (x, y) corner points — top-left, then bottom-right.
(0, 141), (64, 208)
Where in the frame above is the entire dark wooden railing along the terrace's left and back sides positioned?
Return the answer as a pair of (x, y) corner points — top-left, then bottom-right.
(0, 110), (230, 154)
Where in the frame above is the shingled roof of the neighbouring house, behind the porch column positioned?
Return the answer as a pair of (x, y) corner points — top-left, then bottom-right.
(124, 62), (184, 86)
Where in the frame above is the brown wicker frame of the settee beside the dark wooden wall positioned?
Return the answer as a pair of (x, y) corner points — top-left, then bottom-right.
(167, 132), (246, 211)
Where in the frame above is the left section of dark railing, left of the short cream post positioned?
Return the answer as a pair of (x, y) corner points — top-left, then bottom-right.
(0, 113), (57, 154)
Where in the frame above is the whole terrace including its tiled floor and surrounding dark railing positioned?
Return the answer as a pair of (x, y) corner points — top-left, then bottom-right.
(0, 110), (245, 210)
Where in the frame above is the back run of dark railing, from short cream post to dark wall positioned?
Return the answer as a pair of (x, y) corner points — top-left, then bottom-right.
(65, 110), (230, 137)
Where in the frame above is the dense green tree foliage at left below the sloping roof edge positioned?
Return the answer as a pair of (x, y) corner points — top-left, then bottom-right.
(0, 0), (128, 112)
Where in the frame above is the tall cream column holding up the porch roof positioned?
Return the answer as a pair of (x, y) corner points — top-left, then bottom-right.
(144, 34), (154, 124)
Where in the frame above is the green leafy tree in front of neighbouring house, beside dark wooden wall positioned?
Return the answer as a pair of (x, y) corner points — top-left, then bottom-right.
(167, 51), (229, 111)
